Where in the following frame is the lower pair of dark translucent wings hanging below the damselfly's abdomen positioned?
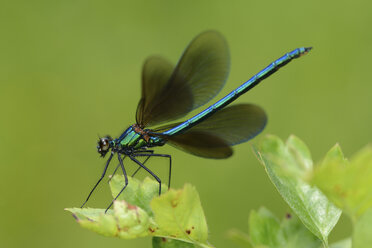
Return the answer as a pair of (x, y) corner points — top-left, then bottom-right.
(160, 104), (267, 158)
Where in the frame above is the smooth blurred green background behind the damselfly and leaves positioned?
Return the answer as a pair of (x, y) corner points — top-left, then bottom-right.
(0, 0), (372, 248)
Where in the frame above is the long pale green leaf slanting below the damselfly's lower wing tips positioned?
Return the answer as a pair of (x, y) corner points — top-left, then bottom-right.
(255, 136), (341, 245)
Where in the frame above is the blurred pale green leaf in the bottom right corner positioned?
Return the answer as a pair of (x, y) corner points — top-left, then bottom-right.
(353, 208), (372, 248)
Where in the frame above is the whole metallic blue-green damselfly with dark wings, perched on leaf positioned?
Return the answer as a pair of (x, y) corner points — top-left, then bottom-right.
(82, 31), (311, 209)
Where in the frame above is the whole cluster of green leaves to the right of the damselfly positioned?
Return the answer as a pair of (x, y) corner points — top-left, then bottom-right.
(230, 135), (372, 248)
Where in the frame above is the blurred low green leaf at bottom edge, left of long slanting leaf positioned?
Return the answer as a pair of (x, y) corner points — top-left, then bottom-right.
(230, 208), (322, 248)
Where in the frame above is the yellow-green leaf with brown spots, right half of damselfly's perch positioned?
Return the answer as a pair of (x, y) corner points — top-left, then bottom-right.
(151, 184), (208, 243)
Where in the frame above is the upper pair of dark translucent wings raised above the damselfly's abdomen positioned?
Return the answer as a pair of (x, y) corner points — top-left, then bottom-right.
(136, 31), (230, 126)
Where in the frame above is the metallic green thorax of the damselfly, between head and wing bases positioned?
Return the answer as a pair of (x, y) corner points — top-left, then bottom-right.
(112, 125), (165, 150)
